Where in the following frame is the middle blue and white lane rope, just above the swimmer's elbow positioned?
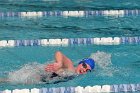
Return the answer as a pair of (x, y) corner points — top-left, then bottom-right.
(0, 37), (140, 47)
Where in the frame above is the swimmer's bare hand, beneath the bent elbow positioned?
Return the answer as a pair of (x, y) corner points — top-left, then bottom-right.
(45, 63), (62, 72)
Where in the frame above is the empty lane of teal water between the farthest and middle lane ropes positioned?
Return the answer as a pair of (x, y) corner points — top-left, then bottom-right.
(0, 16), (140, 40)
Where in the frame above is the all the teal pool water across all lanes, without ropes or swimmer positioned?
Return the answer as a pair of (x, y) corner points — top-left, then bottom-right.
(0, 0), (140, 90)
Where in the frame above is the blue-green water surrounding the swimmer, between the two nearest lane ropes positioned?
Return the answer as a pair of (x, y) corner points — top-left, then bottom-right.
(0, 45), (140, 90)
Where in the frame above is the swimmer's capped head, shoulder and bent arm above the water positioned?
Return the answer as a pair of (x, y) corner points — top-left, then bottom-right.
(45, 51), (95, 76)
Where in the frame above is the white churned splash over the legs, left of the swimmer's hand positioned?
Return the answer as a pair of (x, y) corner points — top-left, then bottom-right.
(8, 63), (45, 84)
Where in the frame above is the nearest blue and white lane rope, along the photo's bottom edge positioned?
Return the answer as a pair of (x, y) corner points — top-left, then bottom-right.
(0, 84), (140, 93)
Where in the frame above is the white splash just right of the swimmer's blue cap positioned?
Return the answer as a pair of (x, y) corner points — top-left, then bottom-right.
(90, 51), (119, 76)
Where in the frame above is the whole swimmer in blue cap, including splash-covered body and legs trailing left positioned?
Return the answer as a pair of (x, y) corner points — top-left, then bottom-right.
(0, 51), (95, 84)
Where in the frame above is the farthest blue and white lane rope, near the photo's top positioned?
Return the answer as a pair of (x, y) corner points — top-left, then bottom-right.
(0, 9), (140, 18)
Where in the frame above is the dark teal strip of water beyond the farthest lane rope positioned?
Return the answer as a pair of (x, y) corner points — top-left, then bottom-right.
(0, 0), (140, 11)
